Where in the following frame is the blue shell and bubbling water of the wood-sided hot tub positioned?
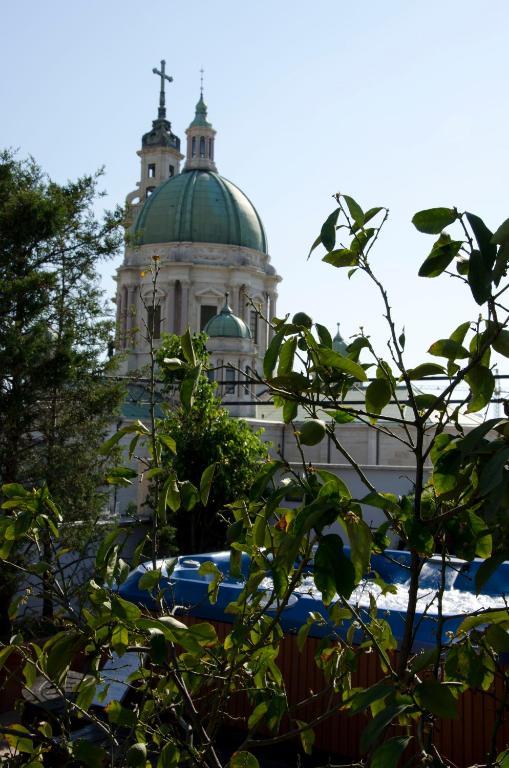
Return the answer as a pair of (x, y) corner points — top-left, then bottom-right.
(119, 547), (509, 650)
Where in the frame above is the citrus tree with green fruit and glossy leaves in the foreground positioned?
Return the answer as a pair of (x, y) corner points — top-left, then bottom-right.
(0, 196), (509, 768)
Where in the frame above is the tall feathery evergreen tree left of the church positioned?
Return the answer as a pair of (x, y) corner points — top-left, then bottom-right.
(0, 152), (122, 628)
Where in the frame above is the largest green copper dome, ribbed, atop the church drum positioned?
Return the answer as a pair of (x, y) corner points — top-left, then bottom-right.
(134, 170), (267, 253)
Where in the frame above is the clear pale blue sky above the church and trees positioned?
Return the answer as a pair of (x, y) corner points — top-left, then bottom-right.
(0, 0), (509, 382)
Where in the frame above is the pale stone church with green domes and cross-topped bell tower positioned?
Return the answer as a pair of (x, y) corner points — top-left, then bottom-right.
(117, 62), (281, 416)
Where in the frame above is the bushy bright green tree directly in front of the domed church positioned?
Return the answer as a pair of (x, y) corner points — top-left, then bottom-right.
(157, 333), (267, 552)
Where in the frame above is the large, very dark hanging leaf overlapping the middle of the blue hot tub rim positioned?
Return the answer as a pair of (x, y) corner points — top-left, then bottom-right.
(314, 533), (355, 605)
